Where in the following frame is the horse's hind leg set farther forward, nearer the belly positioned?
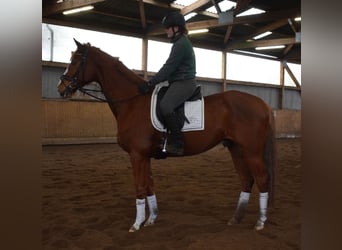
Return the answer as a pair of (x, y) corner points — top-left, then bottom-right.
(228, 145), (254, 225)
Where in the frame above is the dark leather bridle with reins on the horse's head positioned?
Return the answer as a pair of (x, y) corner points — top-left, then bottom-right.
(60, 46), (140, 104)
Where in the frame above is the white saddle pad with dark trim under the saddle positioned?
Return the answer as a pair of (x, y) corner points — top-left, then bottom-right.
(150, 83), (204, 132)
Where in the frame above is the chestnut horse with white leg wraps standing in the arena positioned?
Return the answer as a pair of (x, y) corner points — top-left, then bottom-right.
(58, 40), (276, 232)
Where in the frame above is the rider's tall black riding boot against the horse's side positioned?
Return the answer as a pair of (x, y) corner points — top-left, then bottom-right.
(164, 112), (184, 155)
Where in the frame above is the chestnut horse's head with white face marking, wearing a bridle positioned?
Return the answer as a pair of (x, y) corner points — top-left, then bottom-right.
(57, 39), (89, 97)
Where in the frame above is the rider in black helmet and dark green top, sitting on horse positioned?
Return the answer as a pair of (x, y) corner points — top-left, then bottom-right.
(140, 12), (196, 155)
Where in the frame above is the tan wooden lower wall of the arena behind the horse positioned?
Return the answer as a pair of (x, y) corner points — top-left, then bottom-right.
(42, 100), (301, 145)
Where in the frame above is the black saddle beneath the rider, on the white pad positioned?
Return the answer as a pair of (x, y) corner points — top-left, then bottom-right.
(156, 86), (202, 127)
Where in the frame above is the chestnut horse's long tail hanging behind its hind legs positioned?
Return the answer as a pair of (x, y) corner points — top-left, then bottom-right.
(264, 108), (277, 206)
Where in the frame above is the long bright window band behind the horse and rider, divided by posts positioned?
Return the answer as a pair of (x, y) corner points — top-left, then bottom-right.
(42, 24), (301, 86)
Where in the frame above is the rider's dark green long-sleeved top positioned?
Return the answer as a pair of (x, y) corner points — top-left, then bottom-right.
(150, 35), (196, 85)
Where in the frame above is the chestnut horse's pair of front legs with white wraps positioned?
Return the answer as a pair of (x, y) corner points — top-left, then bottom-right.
(129, 154), (158, 232)
